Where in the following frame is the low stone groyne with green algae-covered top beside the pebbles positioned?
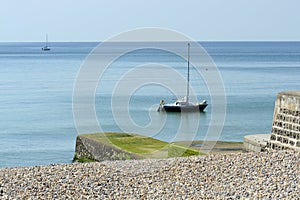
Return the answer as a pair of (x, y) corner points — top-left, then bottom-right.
(74, 132), (201, 161)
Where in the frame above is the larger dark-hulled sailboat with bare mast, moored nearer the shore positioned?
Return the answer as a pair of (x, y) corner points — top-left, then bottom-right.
(157, 43), (208, 112)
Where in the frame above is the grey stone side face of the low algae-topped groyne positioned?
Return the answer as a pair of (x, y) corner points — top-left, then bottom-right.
(75, 135), (138, 161)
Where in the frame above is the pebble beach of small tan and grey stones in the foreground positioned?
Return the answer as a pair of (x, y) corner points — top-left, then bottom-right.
(0, 151), (300, 199)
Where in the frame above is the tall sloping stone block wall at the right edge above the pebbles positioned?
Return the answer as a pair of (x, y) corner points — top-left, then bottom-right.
(267, 91), (300, 151)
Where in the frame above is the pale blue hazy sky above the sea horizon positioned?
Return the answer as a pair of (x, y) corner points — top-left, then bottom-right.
(0, 0), (300, 42)
